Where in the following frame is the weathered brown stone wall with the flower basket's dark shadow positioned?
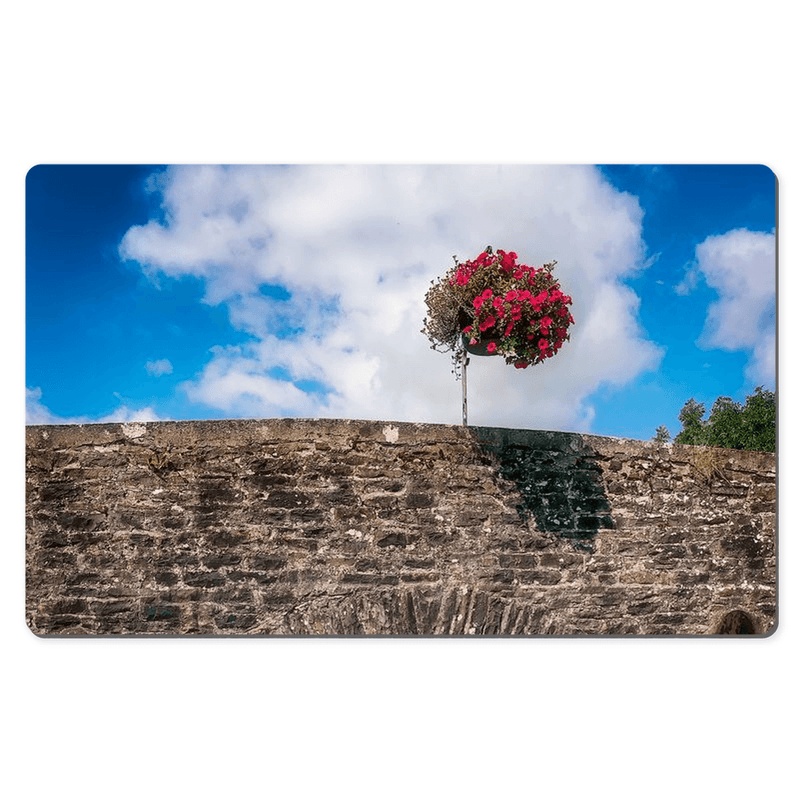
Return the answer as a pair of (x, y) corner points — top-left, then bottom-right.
(26, 419), (776, 635)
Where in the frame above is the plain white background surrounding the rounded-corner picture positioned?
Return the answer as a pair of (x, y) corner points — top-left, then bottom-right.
(0, 0), (798, 798)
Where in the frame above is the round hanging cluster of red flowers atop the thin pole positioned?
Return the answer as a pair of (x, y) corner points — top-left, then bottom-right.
(422, 247), (575, 369)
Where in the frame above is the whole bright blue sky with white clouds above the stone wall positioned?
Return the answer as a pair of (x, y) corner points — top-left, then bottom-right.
(26, 165), (776, 439)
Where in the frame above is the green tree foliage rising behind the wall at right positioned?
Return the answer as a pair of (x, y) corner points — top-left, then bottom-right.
(668, 386), (776, 453)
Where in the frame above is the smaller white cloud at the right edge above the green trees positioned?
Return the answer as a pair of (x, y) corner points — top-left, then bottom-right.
(696, 229), (775, 385)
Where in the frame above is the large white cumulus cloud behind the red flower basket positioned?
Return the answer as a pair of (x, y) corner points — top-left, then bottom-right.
(120, 166), (662, 430)
